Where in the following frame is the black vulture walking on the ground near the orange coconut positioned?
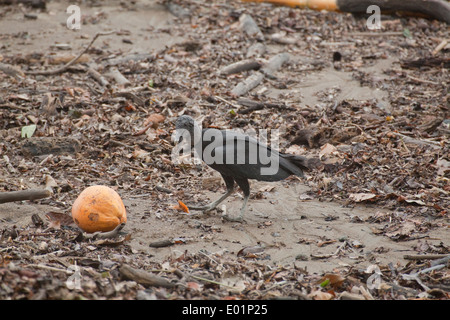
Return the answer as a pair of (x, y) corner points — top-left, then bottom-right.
(175, 115), (315, 221)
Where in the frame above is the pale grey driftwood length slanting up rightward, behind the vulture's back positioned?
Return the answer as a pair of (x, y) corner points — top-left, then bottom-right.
(231, 53), (289, 96)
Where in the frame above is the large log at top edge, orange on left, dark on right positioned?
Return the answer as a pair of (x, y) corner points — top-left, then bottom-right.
(244, 0), (450, 24)
